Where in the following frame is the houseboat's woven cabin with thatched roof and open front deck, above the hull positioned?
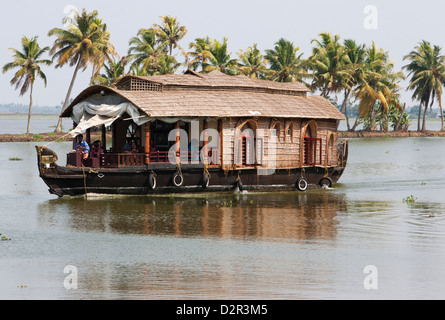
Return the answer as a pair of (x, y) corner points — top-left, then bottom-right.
(62, 71), (343, 171)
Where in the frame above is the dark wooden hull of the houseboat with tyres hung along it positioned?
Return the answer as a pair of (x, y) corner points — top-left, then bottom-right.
(37, 147), (346, 197)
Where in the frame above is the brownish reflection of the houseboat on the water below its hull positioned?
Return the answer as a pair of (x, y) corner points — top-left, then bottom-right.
(39, 190), (346, 240)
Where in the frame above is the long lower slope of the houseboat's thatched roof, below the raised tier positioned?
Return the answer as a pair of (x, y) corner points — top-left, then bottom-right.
(61, 85), (344, 120)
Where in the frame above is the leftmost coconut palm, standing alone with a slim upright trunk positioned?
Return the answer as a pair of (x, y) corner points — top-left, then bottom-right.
(3, 36), (52, 134)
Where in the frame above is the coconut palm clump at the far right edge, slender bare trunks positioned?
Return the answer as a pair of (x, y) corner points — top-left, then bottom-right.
(403, 41), (445, 131)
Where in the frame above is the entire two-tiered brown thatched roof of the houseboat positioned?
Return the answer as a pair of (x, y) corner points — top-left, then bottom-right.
(62, 71), (344, 120)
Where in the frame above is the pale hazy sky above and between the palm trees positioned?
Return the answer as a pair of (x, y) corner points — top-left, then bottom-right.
(0, 0), (445, 106)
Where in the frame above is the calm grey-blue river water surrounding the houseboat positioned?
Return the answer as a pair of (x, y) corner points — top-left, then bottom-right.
(0, 138), (445, 300)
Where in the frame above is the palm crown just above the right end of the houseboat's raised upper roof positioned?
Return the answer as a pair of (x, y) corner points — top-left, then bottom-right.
(264, 38), (307, 82)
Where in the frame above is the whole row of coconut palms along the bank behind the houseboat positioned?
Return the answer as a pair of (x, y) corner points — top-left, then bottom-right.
(3, 9), (445, 133)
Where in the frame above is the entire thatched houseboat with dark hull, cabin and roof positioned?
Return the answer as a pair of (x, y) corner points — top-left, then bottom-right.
(36, 70), (348, 197)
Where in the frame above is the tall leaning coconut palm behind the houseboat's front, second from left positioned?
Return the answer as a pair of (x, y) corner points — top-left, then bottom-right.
(48, 9), (116, 132)
